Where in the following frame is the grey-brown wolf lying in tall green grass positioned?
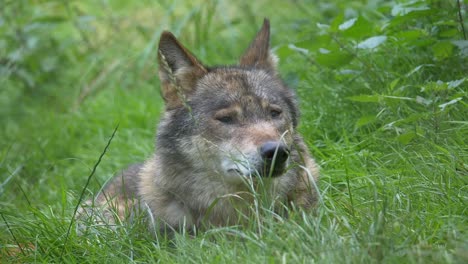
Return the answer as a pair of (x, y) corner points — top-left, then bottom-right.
(83, 19), (319, 231)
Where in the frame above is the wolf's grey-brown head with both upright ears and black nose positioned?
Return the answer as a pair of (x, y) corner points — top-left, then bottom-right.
(157, 19), (298, 184)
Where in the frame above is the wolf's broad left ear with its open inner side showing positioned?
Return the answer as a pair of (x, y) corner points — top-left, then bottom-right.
(158, 31), (207, 109)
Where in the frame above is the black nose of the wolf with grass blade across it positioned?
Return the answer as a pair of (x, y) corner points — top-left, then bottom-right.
(259, 141), (289, 177)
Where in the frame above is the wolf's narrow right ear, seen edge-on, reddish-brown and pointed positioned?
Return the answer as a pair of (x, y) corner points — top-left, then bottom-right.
(239, 18), (278, 72)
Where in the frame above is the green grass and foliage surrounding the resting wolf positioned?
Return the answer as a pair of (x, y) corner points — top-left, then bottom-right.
(0, 0), (468, 263)
